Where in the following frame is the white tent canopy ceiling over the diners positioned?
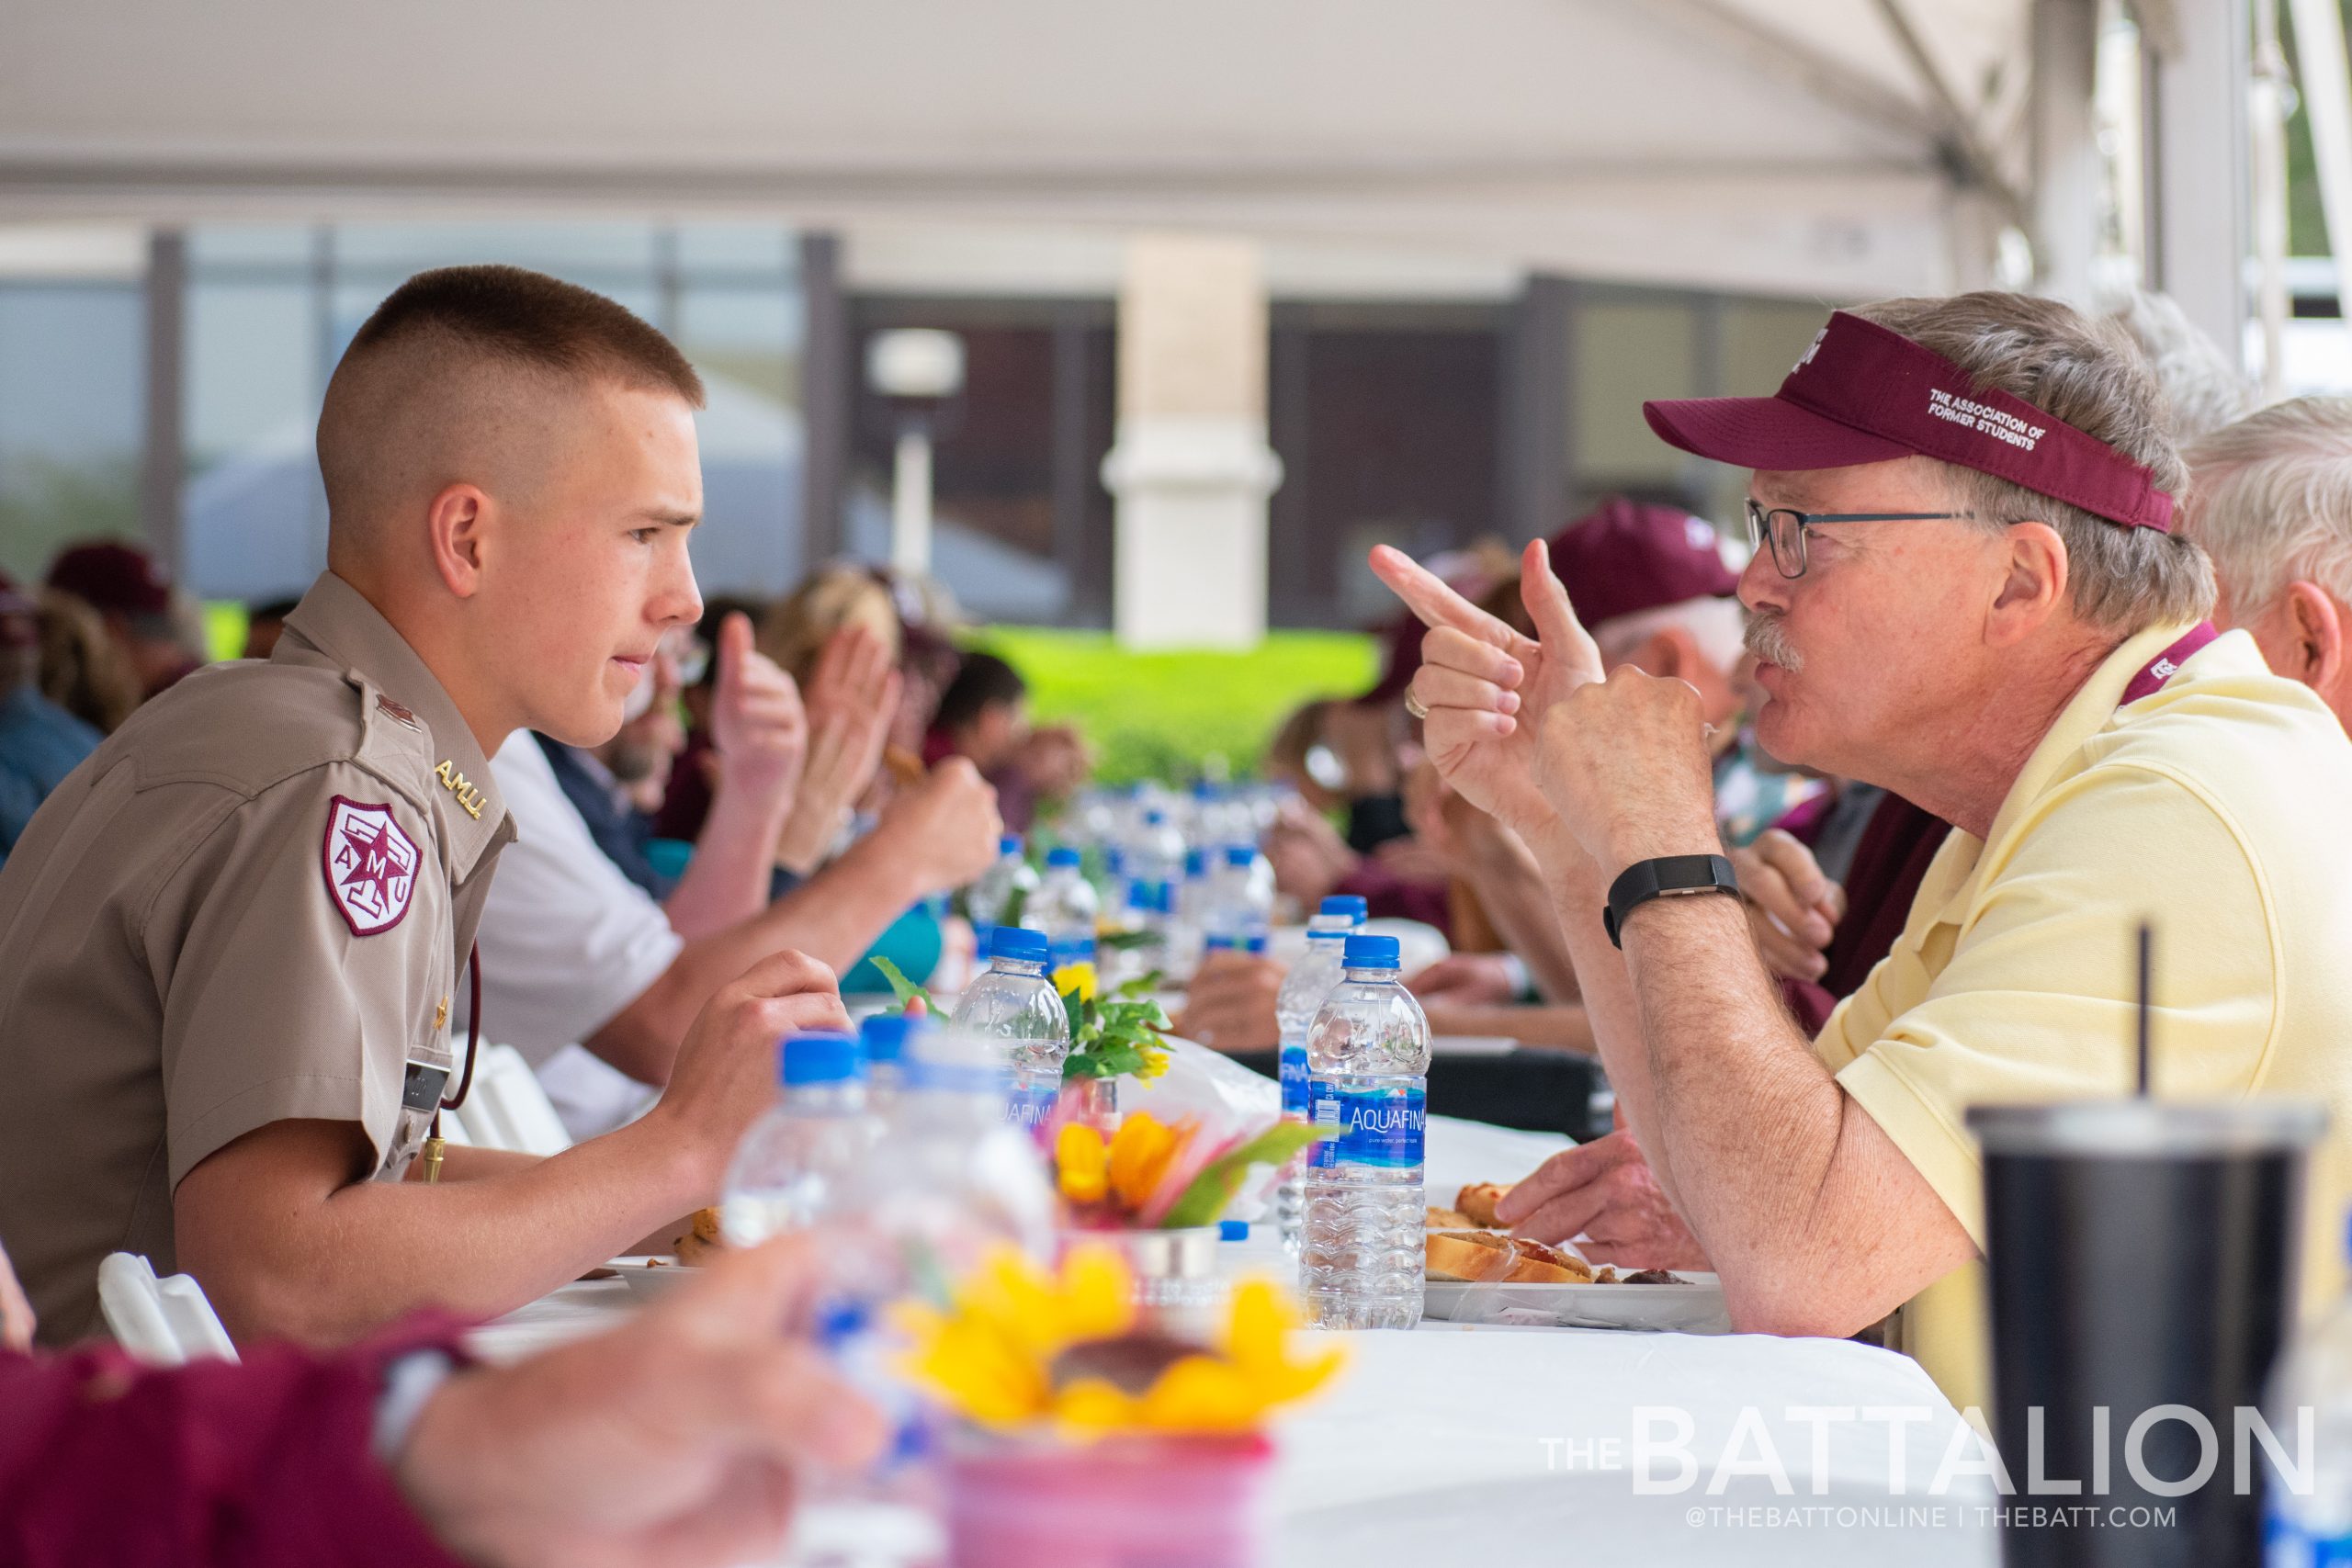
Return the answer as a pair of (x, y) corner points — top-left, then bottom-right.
(0, 0), (2030, 296)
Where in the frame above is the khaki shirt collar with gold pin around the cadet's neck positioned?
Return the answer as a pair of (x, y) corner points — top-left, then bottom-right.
(273, 571), (515, 882)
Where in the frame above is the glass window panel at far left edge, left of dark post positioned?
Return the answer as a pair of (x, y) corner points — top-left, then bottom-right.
(0, 282), (146, 581)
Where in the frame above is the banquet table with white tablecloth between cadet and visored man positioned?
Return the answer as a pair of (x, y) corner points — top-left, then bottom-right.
(475, 1117), (1996, 1568)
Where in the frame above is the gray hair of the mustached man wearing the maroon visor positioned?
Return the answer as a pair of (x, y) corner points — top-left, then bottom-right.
(1853, 291), (2213, 637)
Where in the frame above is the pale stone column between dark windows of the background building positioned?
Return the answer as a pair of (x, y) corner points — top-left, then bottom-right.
(1103, 235), (1282, 649)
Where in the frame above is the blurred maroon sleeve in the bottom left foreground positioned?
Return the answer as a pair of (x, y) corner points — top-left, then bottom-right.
(0, 1324), (472, 1568)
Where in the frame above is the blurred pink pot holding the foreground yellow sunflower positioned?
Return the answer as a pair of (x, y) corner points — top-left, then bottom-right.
(948, 1434), (1275, 1568)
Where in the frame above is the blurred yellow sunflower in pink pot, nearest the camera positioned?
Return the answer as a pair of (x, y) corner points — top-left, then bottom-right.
(899, 1248), (1343, 1568)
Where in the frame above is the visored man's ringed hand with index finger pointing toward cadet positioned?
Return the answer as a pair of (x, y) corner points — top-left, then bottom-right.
(1371, 538), (1601, 851)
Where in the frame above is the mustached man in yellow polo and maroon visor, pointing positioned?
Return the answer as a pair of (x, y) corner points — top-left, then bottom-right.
(1374, 294), (2352, 1404)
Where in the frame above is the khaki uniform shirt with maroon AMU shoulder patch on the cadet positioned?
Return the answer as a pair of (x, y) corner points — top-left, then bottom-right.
(0, 573), (513, 1345)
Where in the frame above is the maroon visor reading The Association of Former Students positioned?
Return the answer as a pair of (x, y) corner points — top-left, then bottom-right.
(1646, 310), (2173, 536)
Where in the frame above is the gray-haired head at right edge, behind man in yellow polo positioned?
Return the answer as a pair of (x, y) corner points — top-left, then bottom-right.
(2185, 398), (2352, 728)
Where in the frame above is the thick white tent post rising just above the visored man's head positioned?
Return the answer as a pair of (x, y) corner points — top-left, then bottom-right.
(2150, 0), (2248, 365)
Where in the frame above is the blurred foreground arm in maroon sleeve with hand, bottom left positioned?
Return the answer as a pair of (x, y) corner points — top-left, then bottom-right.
(0, 1239), (882, 1568)
